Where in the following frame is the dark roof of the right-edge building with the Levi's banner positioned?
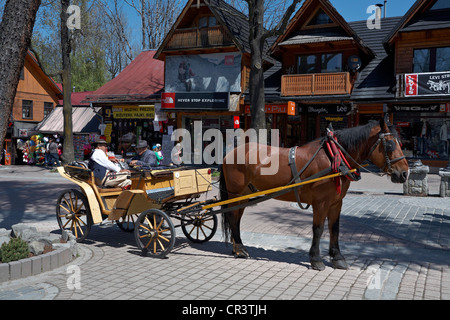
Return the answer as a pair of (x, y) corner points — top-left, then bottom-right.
(383, 0), (450, 51)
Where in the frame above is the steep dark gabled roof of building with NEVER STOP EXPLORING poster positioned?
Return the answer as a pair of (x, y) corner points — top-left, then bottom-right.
(155, 0), (272, 61)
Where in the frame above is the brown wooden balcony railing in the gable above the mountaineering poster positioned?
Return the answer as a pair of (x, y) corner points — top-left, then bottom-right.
(166, 26), (236, 49)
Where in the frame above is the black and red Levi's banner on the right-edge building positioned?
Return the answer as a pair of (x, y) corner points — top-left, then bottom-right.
(405, 72), (450, 97)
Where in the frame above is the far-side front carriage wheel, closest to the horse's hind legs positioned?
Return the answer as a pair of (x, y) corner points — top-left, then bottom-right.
(181, 215), (217, 243)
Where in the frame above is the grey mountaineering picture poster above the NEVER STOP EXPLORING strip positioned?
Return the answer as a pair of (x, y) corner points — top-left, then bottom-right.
(165, 52), (241, 93)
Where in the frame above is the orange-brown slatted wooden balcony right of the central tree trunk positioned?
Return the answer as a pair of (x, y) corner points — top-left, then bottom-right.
(281, 72), (352, 96)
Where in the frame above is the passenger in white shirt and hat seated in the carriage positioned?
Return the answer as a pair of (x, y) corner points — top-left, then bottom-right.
(89, 139), (131, 189)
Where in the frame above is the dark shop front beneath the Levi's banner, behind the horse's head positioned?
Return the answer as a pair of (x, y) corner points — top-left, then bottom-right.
(392, 102), (450, 167)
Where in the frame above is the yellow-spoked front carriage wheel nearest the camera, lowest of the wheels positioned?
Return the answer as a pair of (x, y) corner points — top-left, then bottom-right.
(134, 209), (176, 258)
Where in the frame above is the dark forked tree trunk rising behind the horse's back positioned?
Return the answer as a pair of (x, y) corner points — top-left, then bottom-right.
(209, 0), (301, 132)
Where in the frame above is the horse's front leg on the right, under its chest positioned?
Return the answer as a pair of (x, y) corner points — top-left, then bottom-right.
(328, 200), (348, 269)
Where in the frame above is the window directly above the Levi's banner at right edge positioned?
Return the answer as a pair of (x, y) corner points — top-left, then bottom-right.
(413, 47), (450, 73)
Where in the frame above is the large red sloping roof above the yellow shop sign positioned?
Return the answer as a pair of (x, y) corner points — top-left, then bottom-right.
(85, 50), (164, 104)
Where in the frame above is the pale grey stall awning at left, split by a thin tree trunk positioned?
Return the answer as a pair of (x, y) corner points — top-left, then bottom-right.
(36, 106), (102, 134)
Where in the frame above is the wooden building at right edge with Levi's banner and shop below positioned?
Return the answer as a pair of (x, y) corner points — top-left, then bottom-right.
(384, 0), (450, 167)
